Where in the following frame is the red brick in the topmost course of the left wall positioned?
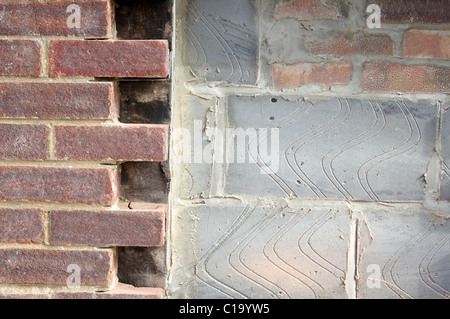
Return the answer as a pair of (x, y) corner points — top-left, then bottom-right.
(0, 0), (113, 38)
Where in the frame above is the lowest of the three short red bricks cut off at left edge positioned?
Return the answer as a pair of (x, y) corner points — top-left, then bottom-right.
(0, 208), (45, 243)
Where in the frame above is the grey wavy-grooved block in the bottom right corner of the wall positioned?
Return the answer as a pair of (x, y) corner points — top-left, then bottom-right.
(357, 211), (450, 299)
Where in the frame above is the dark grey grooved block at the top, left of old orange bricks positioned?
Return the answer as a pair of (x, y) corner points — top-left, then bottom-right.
(183, 0), (258, 85)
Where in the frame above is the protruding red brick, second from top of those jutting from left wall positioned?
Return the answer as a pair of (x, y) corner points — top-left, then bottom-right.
(55, 124), (167, 162)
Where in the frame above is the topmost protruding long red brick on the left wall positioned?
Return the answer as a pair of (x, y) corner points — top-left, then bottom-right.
(49, 40), (169, 78)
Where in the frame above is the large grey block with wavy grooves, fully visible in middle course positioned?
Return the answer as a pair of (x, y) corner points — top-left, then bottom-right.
(225, 96), (438, 201)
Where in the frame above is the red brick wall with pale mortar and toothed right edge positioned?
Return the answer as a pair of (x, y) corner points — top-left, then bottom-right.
(0, 0), (172, 298)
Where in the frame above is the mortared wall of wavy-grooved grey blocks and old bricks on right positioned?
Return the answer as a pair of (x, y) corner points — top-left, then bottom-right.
(171, 0), (450, 299)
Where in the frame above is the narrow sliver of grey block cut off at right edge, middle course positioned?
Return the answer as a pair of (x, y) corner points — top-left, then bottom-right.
(440, 105), (450, 201)
